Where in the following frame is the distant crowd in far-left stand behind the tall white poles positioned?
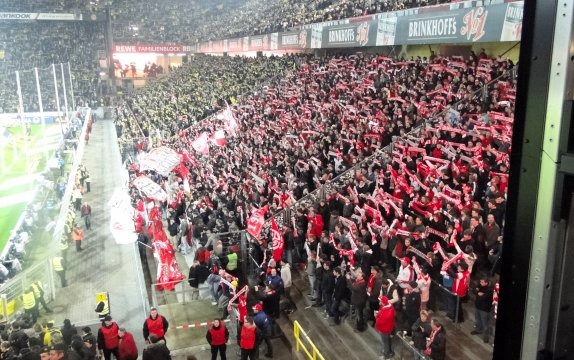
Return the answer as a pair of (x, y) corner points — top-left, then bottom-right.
(0, 21), (105, 112)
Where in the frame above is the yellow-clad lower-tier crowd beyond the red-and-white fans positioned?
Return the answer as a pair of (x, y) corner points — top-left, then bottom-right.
(116, 55), (294, 155)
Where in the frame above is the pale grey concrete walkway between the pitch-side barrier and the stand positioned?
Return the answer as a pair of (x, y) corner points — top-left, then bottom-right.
(38, 116), (149, 351)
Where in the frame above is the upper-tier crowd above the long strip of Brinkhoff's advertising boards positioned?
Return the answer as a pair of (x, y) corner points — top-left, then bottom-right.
(112, 0), (460, 44)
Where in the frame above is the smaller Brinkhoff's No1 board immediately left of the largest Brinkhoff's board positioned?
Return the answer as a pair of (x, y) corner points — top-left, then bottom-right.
(321, 21), (377, 48)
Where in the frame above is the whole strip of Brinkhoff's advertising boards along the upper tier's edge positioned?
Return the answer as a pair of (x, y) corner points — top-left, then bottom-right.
(192, 0), (524, 52)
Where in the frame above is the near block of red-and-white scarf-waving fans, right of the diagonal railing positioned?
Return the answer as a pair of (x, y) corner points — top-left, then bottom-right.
(245, 53), (516, 359)
